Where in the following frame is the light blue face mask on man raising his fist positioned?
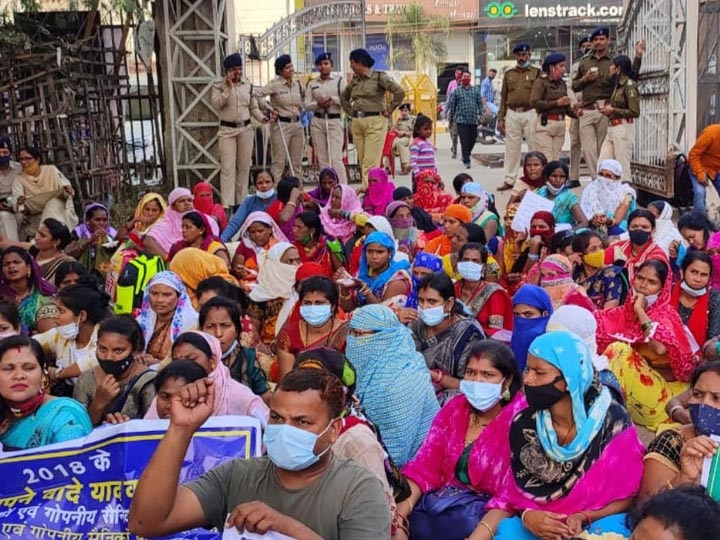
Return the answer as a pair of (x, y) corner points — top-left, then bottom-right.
(263, 420), (332, 471)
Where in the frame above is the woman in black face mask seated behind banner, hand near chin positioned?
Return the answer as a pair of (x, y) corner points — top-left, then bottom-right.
(73, 316), (157, 426)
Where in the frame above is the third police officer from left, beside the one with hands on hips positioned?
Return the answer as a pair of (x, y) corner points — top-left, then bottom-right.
(305, 52), (347, 184)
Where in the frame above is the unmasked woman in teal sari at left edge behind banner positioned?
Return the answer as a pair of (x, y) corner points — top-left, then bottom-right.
(0, 336), (92, 451)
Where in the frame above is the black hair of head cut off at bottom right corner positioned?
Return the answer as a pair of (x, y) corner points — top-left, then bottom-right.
(628, 485), (720, 540)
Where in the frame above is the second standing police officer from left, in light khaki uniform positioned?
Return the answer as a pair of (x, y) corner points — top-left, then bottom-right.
(259, 54), (305, 183)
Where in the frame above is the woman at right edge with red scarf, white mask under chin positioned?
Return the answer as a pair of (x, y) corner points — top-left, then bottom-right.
(670, 251), (720, 359)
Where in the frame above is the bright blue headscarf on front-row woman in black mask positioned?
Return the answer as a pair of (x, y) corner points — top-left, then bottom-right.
(530, 330), (612, 463)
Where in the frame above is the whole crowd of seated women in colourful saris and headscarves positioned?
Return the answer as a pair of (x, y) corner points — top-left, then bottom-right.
(0, 160), (720, 540)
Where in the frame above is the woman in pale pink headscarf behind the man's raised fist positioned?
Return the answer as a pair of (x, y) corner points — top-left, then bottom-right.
(145, 332), (269, 426)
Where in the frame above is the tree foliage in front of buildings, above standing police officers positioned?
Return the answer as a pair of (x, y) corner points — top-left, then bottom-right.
(386, 2), (450, 73)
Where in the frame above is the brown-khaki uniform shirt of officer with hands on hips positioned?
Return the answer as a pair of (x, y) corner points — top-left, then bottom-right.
(342, 69), (405, 114)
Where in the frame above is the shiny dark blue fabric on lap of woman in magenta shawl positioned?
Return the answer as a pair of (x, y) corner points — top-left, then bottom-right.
(408, 486), (490, 540)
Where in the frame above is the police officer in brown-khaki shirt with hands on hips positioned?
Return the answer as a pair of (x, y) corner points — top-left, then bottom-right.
(342, 49), (405, 186)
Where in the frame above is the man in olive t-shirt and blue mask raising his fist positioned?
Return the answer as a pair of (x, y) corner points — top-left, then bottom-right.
(130, 368), (390, 540)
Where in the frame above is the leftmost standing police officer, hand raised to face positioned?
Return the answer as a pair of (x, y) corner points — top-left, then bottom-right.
(210, 53), (265, 208)
